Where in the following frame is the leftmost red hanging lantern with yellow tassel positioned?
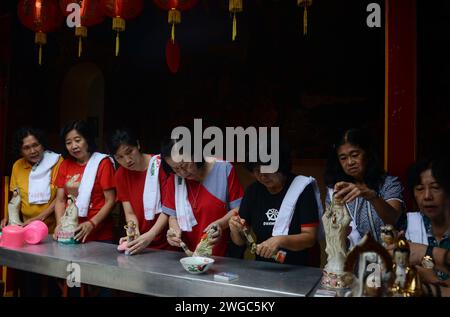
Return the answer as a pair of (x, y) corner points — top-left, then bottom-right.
(17, 0), (63, 65)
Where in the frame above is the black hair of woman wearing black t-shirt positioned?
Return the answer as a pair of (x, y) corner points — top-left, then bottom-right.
(245, 134), (292, 176)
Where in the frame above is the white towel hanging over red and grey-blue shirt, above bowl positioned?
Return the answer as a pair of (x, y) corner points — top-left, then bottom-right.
(173, 175), (197, 231)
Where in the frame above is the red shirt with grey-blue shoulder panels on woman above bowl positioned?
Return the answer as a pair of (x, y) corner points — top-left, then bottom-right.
(163, 161), (244, 256)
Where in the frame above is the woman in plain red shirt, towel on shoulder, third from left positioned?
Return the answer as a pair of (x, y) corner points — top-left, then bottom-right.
(109, 129), (170, 255)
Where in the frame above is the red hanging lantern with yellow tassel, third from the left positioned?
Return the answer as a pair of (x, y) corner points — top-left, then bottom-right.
(101, 0), (144, 56)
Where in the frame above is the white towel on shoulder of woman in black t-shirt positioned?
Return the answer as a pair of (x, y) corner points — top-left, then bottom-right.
(272, 175), (323, 237)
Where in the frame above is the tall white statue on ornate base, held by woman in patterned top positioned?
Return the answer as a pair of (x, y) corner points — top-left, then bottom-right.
(322, 197), (351, 289)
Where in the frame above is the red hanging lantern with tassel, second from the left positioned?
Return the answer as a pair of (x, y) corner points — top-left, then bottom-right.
(59, 0), (104, 57)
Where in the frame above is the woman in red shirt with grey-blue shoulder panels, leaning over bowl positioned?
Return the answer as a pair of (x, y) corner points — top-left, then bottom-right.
(161, 136), (243, 256)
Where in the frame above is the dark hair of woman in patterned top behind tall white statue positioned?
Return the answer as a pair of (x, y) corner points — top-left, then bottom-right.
(324, 129), (386, 193)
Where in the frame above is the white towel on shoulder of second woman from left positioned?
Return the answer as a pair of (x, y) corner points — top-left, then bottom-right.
(76, 152), (109, 217)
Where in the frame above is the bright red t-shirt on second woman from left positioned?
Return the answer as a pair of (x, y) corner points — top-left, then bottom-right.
(55, 158), (115, 241)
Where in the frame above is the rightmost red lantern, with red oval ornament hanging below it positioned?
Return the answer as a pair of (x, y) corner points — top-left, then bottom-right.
(154, 0), (198, 73)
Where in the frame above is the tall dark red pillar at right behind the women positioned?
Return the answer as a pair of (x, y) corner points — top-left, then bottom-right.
(384, 0), (417, 183)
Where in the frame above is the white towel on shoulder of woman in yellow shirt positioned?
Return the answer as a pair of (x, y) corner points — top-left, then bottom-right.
(28, 151), (61, 205)
